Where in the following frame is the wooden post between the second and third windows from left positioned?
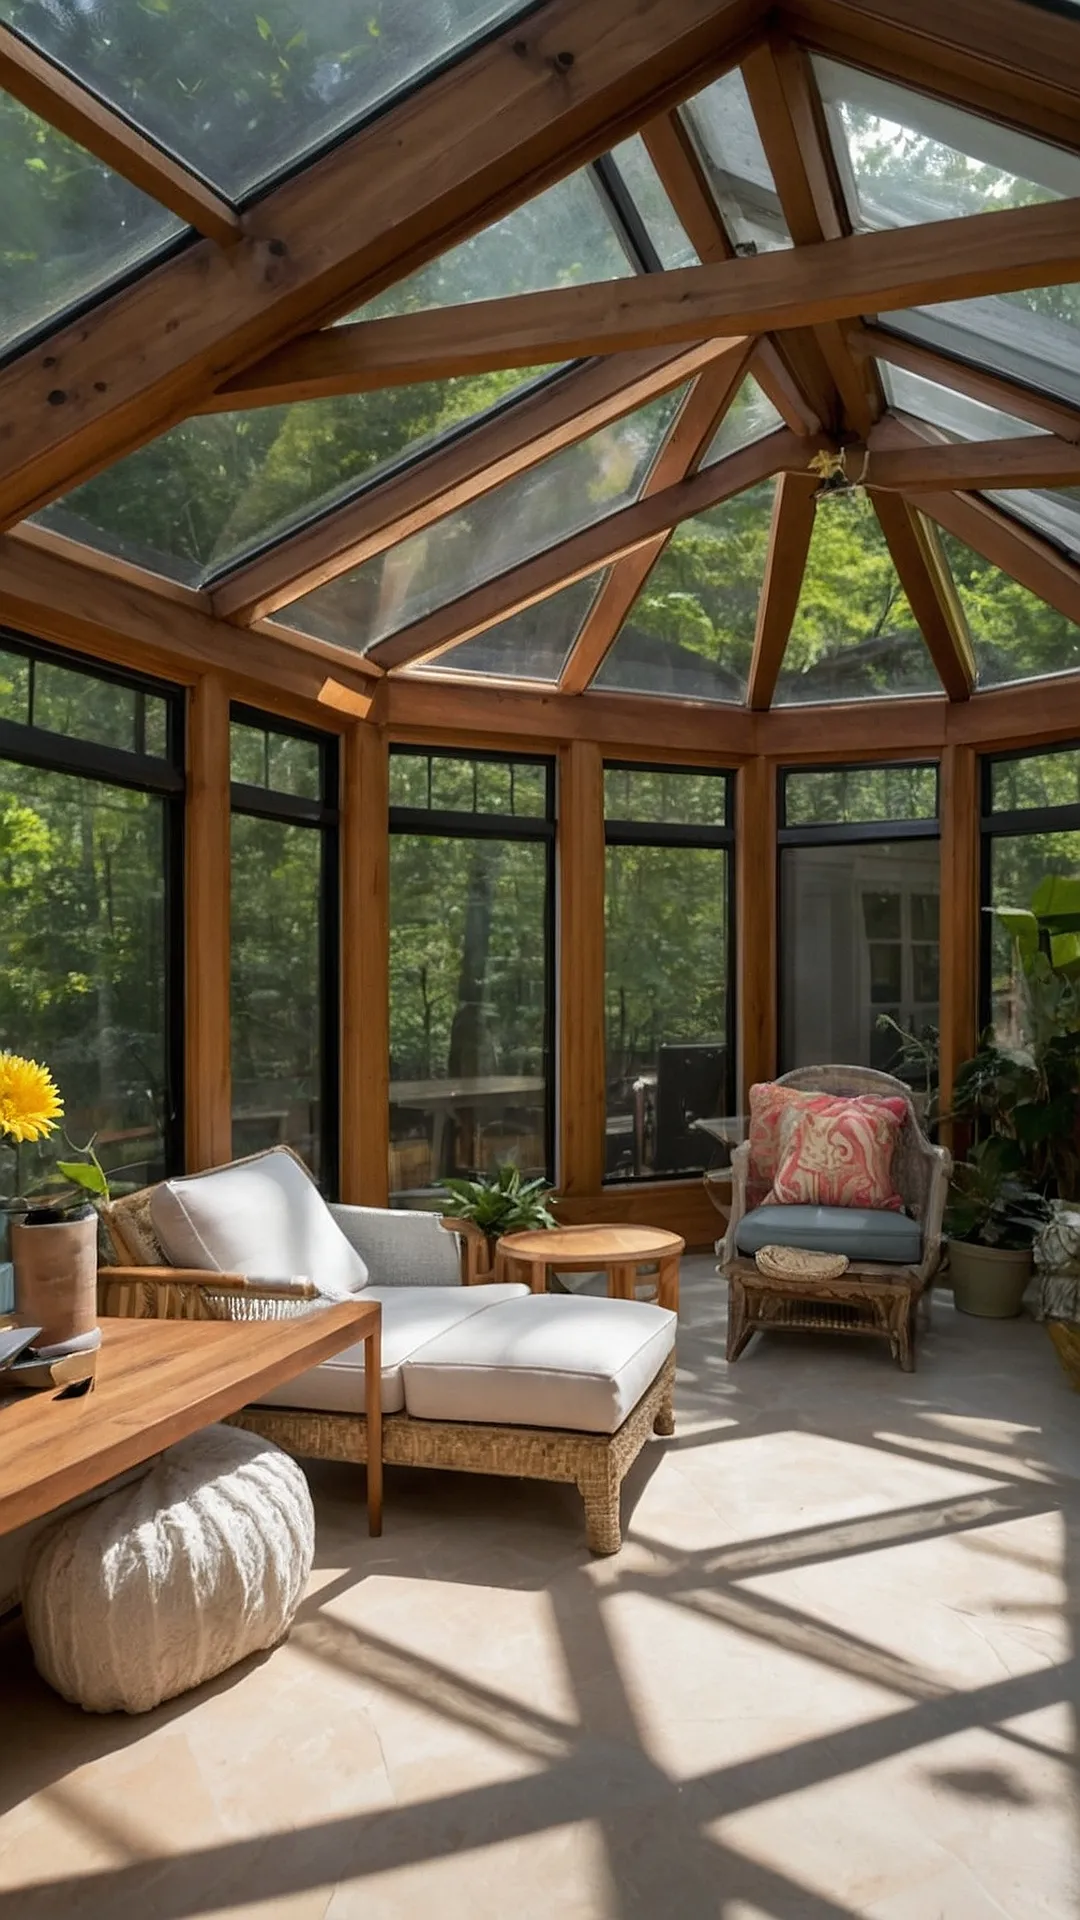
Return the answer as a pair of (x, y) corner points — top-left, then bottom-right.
(340, 720), (390, 1206)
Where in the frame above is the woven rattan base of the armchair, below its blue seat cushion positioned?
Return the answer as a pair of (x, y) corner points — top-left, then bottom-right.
(724, 1256), (922, 1373)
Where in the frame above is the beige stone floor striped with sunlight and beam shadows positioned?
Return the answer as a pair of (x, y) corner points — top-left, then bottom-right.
(0, 1260), (1080, 1920)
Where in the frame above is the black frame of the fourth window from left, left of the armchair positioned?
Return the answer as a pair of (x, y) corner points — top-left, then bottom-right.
(600, 758), (738, 1192)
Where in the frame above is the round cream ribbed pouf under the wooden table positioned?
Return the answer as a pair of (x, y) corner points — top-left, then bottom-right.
(23, 1427), (315, 1713)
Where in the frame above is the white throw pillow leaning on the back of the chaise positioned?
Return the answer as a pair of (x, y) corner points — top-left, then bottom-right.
(150, 1146), (367, 1294)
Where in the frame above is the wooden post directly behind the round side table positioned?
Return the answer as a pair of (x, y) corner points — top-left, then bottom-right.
(557, 741), (605, 1194)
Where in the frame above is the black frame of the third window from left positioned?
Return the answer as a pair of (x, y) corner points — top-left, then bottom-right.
(388, 741), (561, 1200)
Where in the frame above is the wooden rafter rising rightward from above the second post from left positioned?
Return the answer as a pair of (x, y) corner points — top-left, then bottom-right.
(369, 428), (821, 670)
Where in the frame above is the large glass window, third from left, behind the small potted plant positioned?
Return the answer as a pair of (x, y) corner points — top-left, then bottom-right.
(390, 747), (555, 1194)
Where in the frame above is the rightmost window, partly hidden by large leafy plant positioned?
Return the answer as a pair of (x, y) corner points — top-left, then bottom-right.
(980, 745), (1080, 1046)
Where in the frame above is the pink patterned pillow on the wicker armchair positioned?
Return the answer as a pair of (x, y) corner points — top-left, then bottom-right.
(767, 1096), (907, 1212)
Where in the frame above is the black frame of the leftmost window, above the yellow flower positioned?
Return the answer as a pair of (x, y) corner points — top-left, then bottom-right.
(0, 624), (188, 1177)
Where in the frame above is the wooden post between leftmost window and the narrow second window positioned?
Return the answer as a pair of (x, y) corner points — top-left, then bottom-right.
(184, 674), (233, 1173)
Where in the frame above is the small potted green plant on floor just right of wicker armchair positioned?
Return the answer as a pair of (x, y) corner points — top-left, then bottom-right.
(945, 1133), (1051, 1319)
